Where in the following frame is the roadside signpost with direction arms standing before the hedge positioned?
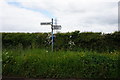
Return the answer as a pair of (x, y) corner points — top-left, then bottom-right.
(41, 18), (61, 51)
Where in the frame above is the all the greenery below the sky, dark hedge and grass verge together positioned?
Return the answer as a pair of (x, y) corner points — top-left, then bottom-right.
(2, 31), (120, 78)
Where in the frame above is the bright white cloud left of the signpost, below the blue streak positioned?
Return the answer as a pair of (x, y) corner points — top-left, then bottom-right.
(1, 1), (50, 32)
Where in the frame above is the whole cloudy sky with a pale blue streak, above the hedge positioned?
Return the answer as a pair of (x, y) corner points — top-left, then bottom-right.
(0, 0), (119, 33)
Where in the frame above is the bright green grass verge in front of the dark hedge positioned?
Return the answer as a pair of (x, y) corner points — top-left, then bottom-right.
(2, 49), (119, 78)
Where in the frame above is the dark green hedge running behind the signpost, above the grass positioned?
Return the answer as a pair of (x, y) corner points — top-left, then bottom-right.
(2, 31), (120, 52)
